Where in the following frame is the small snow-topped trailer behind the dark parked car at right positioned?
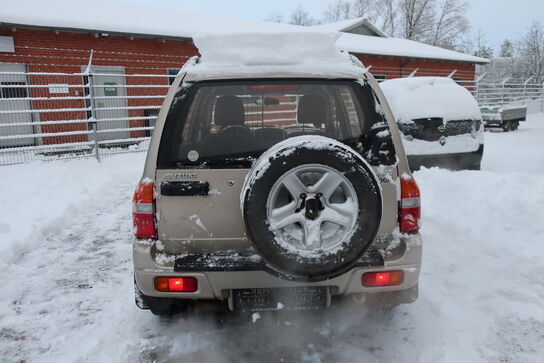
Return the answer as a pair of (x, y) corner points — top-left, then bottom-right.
(480, 104), (527, 132)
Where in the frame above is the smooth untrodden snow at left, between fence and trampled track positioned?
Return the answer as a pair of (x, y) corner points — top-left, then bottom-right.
(0, 153), (145, 267)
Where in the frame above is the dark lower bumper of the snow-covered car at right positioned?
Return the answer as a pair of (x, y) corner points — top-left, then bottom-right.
(408, 144), (484, 170)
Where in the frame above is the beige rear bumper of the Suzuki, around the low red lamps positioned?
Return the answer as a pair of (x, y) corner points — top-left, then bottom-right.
(133, 235), (422, 300)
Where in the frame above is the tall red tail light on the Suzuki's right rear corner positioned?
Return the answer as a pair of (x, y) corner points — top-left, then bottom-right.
(399, 177), (421, 233)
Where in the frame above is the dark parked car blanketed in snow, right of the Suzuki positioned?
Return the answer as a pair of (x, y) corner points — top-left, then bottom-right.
(380, 77), (484, 170)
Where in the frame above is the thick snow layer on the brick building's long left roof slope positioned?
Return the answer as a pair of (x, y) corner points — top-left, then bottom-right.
(0, 0), (300, 38)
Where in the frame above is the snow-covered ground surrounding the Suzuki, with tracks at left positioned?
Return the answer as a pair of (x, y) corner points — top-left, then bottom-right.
(0, 114), (544, 362)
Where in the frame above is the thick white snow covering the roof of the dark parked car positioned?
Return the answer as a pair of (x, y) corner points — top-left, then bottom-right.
(380, 77), (482, 123)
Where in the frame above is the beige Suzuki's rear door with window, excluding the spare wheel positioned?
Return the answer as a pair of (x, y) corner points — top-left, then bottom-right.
(155, 81), (398, 253)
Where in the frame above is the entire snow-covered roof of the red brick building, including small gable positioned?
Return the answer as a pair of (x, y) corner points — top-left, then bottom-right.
(0, 0), (488, 64)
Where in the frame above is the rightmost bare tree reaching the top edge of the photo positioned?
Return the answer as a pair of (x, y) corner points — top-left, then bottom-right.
(430, 0), (470, 49)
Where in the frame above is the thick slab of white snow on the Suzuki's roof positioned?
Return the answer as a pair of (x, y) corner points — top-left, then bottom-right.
(184, 32), (364, 78)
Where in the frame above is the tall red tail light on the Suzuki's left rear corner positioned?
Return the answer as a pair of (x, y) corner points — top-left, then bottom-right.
(132, 181), (157, 239)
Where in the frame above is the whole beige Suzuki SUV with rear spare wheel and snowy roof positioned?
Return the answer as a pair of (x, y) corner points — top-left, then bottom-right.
(133, 33), (422, 314)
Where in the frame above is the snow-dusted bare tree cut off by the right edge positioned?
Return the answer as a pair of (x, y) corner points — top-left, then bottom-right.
(520, 21), (544, 83)
